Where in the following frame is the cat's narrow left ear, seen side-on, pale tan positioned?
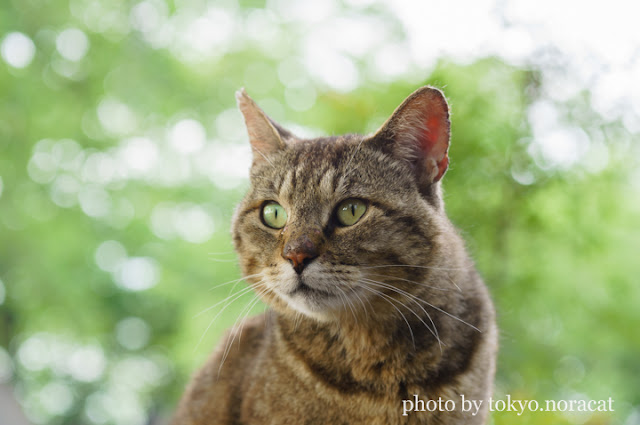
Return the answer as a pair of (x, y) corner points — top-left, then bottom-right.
(236, 89), (289, 162)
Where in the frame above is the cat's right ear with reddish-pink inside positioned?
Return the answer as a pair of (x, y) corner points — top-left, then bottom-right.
(373, 86), (451, 184)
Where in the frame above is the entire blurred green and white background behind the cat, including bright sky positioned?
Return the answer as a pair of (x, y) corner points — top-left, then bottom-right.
(0, 0), (640, 425)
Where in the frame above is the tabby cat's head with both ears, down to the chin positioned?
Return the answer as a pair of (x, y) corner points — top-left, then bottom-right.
(233, 87), (450, 320)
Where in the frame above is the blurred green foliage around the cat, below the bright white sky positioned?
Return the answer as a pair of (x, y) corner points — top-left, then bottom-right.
(0, 0), (640, 424)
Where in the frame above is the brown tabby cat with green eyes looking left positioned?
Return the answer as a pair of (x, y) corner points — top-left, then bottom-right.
(173, 86), (497, 425)
